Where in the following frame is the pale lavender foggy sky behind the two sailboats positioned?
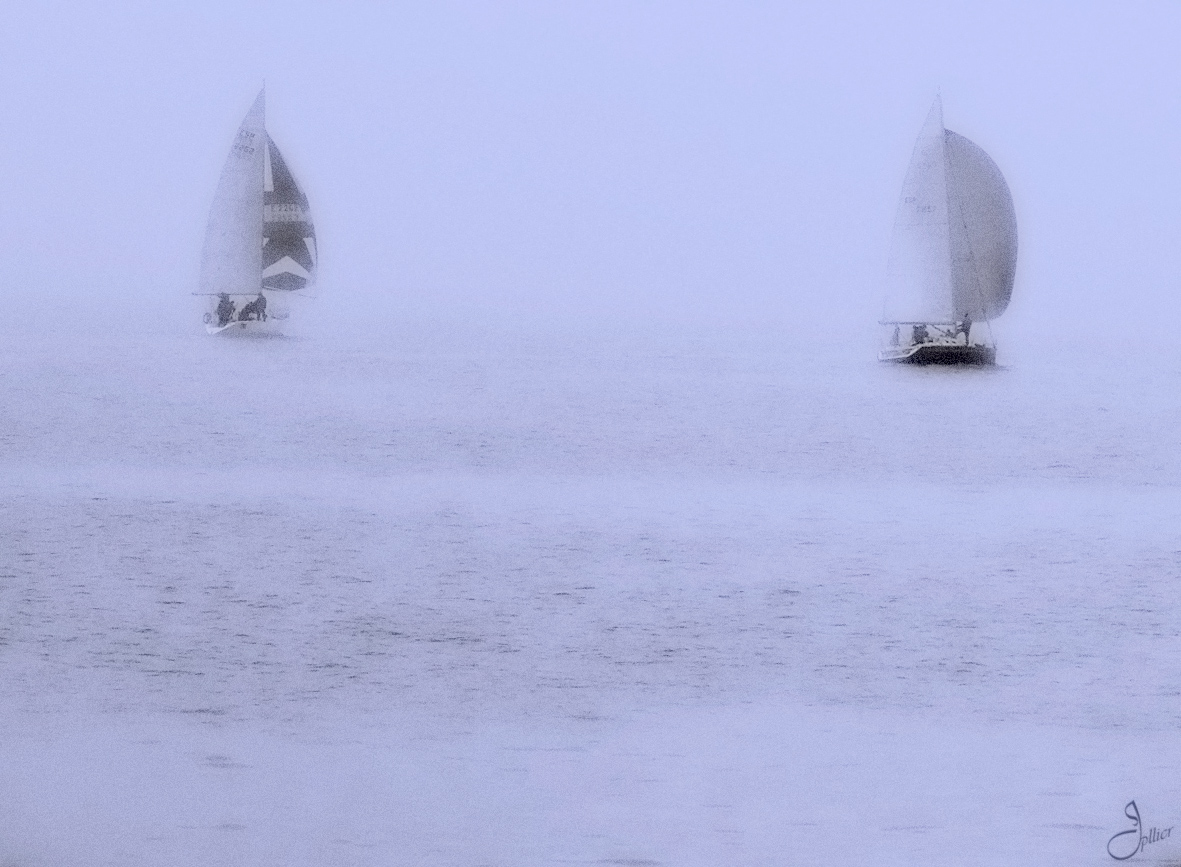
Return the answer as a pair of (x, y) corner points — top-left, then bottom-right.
(0, 1), (1181, 333)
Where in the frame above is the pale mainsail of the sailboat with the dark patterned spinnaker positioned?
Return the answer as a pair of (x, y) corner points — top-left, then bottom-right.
(201, 92), (267, 294)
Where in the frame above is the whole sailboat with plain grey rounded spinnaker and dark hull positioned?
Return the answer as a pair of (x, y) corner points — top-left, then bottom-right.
(877, 97), (1017, 364)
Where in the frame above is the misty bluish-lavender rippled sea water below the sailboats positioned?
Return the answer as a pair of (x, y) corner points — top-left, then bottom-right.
(0, 302), (1181, 865)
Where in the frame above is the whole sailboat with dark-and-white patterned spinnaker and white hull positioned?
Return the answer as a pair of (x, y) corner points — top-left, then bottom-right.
(197, 89), (318, 334)
